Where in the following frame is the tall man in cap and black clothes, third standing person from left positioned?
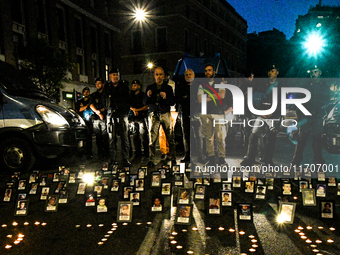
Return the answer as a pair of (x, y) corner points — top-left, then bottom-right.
(106, 68), (131, 166)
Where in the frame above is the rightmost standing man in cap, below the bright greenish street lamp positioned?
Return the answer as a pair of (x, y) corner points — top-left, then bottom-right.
(291, 65), (330, 166)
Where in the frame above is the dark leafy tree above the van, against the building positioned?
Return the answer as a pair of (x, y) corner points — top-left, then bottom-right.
(20, 39), (73, 102)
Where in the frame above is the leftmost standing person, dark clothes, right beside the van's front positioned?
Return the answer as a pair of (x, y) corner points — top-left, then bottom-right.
(76, 87), (93, 159)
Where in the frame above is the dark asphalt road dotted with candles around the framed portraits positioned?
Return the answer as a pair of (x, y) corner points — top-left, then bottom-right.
(0, 132), (340, 254)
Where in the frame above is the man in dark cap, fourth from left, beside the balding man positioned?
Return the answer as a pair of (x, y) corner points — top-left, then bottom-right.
(129, 80), (149, 158)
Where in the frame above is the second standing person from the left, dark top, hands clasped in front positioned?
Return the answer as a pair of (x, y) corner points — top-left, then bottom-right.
(89, 78), (109, 160)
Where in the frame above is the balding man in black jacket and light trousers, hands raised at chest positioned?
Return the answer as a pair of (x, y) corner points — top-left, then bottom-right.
(144, 67), (176, 167)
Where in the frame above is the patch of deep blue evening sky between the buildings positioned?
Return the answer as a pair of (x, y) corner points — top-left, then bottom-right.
(227, 0), (340, 39)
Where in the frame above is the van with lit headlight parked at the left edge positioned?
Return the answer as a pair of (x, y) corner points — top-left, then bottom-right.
(0, 61), (87, 171)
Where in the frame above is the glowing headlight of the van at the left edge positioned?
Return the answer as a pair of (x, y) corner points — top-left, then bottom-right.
(35, 105), (70, 128)
